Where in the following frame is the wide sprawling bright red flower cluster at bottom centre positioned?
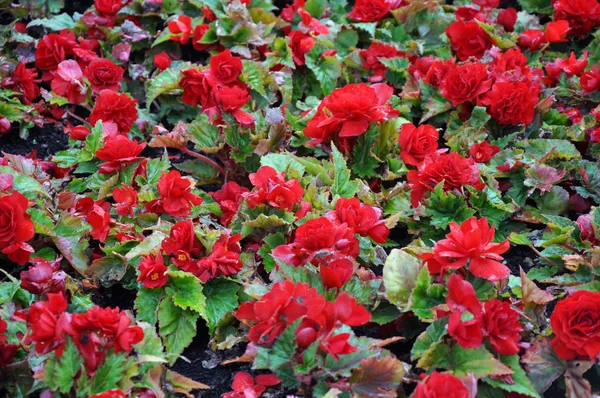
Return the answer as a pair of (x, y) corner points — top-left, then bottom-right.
(235, 281), (371, 360)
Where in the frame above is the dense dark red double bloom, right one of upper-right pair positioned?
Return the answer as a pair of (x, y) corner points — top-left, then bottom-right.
(481, 81), (539, 125)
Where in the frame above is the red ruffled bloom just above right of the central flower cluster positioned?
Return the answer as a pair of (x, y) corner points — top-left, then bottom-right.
(335, 198), (390, 243)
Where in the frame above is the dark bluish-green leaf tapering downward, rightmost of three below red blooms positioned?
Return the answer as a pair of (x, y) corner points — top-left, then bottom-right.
(204, 278), (239, 335)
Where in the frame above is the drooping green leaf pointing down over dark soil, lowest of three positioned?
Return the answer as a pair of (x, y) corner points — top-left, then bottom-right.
(158, 299), (199, 364)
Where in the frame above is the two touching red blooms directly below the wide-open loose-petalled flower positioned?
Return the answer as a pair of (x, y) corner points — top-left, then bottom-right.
(446, 274), (523, 355)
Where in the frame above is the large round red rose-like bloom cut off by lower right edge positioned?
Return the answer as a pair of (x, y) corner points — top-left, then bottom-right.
(550, 290), (600, 360)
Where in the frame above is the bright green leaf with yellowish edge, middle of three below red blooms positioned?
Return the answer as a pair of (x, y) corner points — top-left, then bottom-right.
(167, 271), (206, 314)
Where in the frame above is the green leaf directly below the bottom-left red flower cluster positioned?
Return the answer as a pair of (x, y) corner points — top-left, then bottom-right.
(44, 338), (83, 394)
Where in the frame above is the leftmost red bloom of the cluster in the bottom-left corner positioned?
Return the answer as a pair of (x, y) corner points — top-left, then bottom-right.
(26, 293), (69, 354)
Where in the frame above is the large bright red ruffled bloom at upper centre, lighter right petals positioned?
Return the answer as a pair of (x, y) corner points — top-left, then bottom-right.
(304, 83), (394, 146)
